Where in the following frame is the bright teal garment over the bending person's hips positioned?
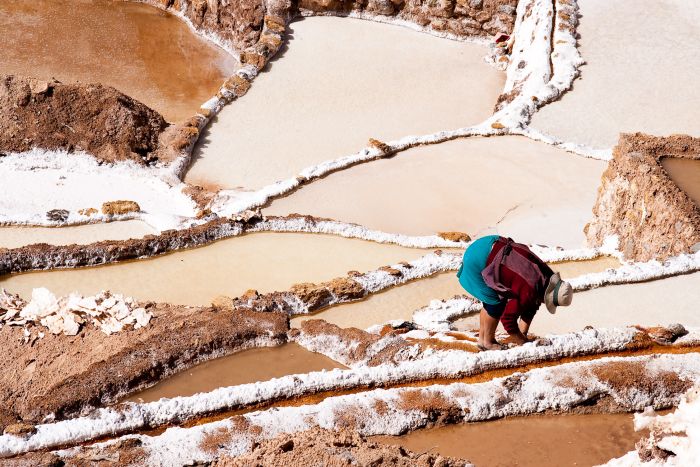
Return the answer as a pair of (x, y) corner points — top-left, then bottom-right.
(457, 235), (501, 305)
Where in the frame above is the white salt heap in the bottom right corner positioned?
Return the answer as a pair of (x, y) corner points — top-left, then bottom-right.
(604, 385), (700, 467)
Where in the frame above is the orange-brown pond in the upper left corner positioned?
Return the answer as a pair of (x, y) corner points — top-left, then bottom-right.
(0, 0), (238, 121)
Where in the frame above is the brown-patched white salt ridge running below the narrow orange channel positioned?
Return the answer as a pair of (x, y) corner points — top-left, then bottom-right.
(56, 354), (700, 465)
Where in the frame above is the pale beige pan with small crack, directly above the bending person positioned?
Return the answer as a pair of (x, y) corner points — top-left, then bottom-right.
(265, 136), (605, 247)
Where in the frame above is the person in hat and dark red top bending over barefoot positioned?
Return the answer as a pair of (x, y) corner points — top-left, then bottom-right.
(457, 235), (574, 350)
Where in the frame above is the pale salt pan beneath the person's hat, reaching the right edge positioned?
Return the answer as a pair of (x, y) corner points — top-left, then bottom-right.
(455, 273), (700, 335)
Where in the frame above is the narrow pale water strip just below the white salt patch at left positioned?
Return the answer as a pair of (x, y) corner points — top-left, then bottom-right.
(0, 220), (157, 248)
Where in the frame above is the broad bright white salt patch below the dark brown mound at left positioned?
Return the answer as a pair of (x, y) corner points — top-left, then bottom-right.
(0, 149), (197, 230)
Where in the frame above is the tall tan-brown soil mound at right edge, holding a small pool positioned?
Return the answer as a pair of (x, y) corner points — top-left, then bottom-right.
(585, 133), (700, 261)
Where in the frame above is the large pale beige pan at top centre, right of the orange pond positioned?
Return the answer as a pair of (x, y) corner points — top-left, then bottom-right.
(186, 18), (504, 188)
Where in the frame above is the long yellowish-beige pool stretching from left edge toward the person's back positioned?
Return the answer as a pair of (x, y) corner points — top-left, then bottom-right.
(0, 233), (426, 305)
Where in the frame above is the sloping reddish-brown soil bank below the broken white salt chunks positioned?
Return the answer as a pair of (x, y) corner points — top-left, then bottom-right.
(0, 304), (288, 428)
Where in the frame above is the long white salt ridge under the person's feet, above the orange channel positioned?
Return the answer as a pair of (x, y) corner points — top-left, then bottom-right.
(0, 328), (700, 457)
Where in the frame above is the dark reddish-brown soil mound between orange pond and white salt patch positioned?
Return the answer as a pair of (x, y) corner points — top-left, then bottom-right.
(0, 76), (168, 163)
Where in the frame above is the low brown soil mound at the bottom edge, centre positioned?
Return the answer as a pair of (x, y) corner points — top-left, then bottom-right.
(215, 429), (468, 467)
